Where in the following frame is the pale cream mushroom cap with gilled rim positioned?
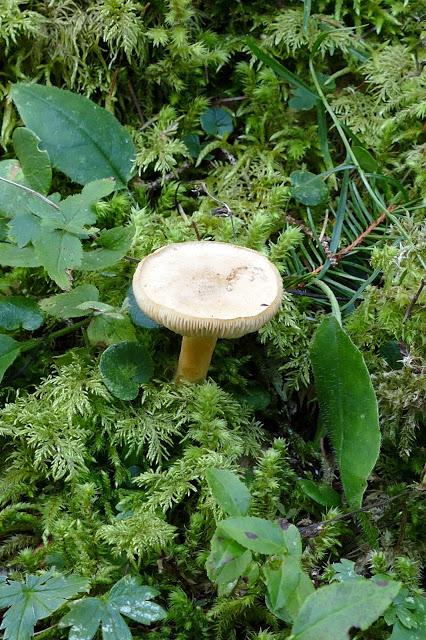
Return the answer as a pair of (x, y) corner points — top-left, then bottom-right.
(133, 241), (283, 338)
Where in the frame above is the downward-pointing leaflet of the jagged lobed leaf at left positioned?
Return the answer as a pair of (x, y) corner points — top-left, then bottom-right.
(34, 228), (83, 289)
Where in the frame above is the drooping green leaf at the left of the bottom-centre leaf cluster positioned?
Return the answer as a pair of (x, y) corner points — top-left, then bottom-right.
(206, 534), (252, 595)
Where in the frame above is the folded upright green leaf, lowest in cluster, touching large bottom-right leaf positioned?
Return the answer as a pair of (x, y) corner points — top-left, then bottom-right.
(263, 556), (314, 623)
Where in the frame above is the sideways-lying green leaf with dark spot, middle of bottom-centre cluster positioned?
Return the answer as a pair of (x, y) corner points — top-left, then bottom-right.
(217, 516), (287, 554)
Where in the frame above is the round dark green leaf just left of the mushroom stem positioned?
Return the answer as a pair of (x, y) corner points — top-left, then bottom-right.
(99, 341), (154, 400)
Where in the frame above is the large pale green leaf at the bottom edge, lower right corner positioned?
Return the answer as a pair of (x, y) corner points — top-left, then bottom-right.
(291, 579), (401, 640)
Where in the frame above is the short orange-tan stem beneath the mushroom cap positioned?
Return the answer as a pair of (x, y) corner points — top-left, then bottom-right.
(176, 336), (217, 382)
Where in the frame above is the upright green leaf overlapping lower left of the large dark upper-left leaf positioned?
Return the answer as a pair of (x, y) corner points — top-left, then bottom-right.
(12, 127), (52, 195)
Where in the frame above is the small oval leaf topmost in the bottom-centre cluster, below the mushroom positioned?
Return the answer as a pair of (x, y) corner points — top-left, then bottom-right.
(206, 469), (251, 516)
